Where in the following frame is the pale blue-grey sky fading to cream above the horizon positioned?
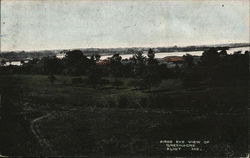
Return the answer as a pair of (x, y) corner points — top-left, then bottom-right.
(0, 0), (250, 51)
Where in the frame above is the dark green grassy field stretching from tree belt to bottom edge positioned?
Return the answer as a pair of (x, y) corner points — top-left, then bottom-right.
(1, 75), (247, 157)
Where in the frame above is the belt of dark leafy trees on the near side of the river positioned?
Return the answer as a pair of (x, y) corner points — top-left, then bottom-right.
(0, 48), (249, 89)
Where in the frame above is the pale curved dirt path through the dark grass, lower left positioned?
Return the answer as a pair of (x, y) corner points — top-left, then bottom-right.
(30, 113), (53, 152)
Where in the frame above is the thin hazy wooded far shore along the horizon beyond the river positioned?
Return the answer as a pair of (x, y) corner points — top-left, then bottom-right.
(0, 43), (250, 61)
